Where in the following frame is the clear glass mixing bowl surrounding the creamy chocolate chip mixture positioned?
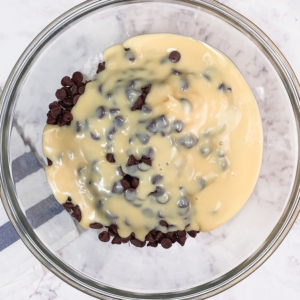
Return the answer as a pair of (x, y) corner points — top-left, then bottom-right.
(0, 0), (299, 299)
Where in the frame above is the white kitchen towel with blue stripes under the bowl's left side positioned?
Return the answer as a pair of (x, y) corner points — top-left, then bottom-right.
(0, 128), (78, 299)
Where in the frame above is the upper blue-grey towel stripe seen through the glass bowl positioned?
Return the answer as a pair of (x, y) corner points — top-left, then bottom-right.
(12, 152), (42, 183)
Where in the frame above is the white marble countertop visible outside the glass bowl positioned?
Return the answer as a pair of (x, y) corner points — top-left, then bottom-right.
(0, 0), (300, 300)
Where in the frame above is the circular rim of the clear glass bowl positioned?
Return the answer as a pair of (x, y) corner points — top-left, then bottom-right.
(0, 0), (300, 299)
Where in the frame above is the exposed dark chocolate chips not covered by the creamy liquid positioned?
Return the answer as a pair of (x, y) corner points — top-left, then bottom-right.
(47, 58), (199, 249)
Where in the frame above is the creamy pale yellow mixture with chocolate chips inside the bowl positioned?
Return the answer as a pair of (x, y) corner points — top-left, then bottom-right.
(43, 34), (263, 248)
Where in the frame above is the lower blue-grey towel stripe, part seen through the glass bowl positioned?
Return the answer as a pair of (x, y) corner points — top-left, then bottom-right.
(25, 195), (64, 229)
